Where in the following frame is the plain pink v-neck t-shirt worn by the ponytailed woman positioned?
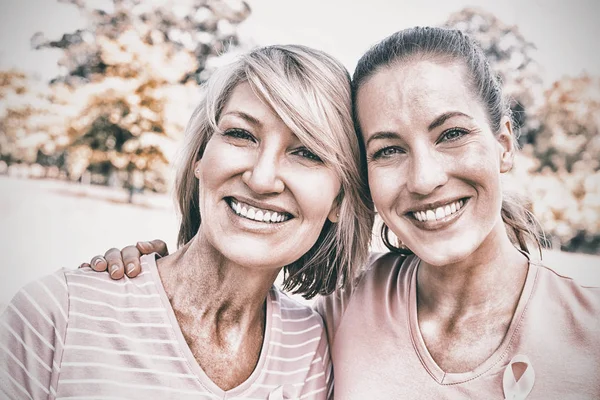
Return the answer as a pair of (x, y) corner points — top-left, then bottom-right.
(317, 253), (600, 400)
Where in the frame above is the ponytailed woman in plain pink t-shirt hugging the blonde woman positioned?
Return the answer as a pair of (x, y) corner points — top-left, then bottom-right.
(79, 28), (600, 400)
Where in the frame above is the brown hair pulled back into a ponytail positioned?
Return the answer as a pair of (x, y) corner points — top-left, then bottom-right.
(352, 27), (543, 254)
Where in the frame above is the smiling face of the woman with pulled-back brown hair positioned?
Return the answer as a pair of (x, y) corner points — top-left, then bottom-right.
(357, 60), (512, 265)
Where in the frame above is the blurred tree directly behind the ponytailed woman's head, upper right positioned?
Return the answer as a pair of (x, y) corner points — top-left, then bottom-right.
(445, 8), (543, 145)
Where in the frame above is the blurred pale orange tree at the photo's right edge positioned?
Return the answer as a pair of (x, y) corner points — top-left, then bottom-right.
(527, 75), (600, 253)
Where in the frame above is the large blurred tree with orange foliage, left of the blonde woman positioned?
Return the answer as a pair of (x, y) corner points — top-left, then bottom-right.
(31, 0), (250, 191)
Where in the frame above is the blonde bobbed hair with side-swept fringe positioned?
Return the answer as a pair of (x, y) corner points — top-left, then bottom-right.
(175, 45), (374, 298)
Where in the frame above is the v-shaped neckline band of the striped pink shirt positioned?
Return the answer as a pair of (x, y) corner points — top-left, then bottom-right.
(141, 253), (279, 398)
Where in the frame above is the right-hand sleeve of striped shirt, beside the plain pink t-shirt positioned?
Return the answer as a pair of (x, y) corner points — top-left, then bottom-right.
(298, 322), (333, 400)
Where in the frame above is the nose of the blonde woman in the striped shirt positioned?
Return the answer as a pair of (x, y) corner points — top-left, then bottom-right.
(242, 151), (285, 194)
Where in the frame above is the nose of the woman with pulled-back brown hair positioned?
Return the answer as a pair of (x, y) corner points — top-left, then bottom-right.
(407, 149), (448, 195)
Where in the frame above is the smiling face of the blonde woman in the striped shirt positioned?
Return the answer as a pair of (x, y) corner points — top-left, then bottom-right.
(195, 83), (340, 268)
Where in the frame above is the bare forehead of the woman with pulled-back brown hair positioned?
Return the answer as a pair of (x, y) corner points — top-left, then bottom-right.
(357, 60), (485, 137)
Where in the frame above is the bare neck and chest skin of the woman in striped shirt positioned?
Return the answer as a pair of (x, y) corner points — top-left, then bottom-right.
(157, 236), (279, 390)
